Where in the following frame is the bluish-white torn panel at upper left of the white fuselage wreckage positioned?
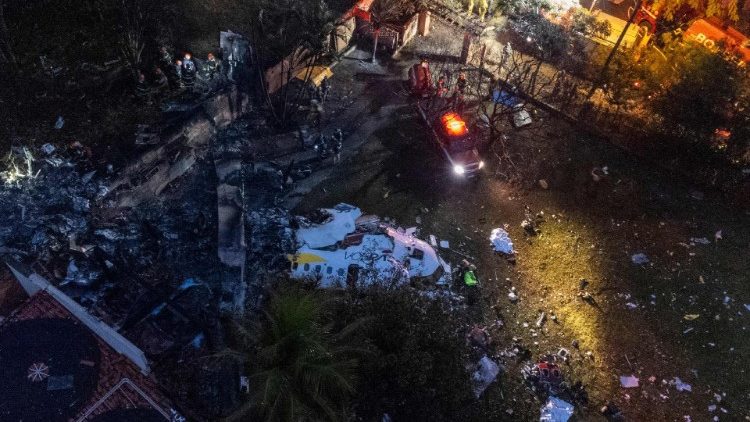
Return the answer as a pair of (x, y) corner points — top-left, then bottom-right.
(297, 204), (362, 249)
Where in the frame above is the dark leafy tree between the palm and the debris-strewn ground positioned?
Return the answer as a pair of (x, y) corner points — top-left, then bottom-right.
(340, 288), (473, 421)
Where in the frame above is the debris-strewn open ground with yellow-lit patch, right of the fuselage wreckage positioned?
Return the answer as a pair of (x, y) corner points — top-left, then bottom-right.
(296, 31), (750, 421)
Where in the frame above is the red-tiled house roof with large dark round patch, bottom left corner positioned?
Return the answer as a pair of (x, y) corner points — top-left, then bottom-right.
(0, 266), (179, 422)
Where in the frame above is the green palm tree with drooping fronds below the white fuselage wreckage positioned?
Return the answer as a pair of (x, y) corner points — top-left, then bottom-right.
(228, 288), (365, 422)
